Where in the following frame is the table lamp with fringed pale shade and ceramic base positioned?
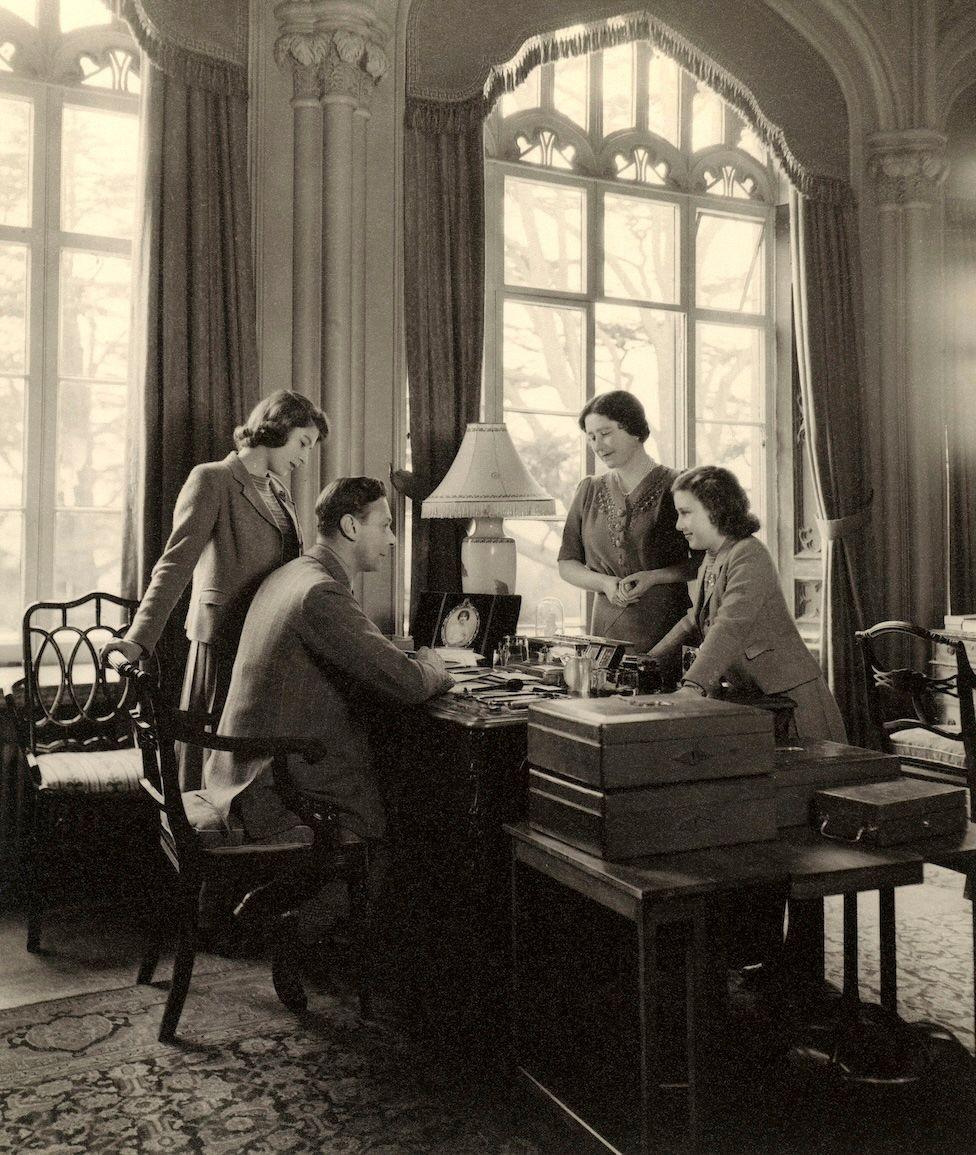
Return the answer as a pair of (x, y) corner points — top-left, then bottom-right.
(420, 423), (556, 594)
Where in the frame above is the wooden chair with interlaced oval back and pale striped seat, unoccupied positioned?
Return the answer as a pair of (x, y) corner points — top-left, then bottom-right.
(6, 593), (150, 952)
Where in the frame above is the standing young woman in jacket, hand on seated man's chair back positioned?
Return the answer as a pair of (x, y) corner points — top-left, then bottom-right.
(102, 389), (329, 790)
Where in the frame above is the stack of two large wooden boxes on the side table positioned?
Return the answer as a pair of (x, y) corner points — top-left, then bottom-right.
(528, 694), (776, 860)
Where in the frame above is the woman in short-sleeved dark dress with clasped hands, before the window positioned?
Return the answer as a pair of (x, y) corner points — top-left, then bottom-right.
(559, 389), (701, 680)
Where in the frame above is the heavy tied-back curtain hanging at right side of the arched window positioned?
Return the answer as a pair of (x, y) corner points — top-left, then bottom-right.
(790, 189), (876, 745)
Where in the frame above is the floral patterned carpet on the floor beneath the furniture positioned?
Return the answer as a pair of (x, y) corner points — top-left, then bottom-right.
(0, 872), (976, 1155)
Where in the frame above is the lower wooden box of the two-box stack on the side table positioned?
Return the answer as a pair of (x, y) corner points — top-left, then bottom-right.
(528, 767), (776, 862)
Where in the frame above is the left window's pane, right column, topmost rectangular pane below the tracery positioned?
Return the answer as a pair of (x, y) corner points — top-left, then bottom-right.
(61, 104), (139, 237)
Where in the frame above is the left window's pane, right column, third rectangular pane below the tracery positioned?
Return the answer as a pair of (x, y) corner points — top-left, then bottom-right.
(58, 381), (126, 509)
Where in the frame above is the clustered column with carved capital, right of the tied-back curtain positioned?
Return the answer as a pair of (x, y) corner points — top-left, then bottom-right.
(867, 128), (947, 625)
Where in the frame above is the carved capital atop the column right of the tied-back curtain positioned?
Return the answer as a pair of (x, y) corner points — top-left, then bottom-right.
(867, 128), (949, 210)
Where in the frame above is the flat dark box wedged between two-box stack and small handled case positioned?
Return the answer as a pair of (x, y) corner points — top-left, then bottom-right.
(773, 742), (901, 827)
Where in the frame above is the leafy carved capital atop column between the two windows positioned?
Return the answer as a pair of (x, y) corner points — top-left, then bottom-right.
(275, 0), (390, 109)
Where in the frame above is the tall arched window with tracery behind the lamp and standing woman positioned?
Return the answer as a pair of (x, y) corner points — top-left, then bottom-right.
(485, 33), (789, 625)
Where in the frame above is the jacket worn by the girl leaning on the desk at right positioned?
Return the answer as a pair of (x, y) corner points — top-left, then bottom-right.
(650, 537), (821, 694)
